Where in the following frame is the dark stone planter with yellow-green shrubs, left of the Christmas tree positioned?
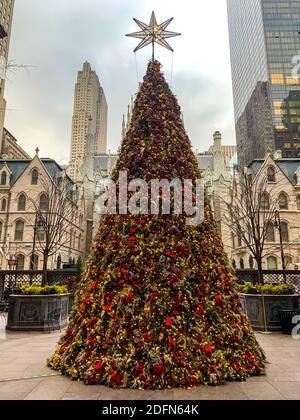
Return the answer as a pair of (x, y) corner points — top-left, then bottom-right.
(6, 286), (70, 331)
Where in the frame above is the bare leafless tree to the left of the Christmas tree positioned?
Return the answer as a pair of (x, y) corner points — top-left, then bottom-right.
(30, 173), (75, 286)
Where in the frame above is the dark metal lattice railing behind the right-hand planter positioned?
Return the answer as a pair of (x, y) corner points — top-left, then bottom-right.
(235, 270), (300, 294)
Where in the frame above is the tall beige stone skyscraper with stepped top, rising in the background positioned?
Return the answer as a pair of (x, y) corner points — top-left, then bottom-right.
(68, 62), (107, 180)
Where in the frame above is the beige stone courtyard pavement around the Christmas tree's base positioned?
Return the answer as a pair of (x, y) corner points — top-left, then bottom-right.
(0, 319), (300, 400)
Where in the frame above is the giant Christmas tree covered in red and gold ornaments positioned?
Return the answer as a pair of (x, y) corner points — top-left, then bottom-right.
(50, 60), (265, 389)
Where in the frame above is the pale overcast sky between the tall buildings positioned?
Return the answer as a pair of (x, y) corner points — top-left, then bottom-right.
(5, 0), (235, 163)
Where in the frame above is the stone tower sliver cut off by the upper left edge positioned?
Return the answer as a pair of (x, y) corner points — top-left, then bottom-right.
(0, 0), (14, 153)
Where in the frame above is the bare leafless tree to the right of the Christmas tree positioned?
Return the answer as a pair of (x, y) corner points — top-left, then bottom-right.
(220, 171), (278, 283)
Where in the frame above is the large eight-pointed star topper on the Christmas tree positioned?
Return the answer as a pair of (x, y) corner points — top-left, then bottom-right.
(126, 12), (181, 60)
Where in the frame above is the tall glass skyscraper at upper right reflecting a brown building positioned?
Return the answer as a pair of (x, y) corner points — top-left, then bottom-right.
(227, 0), (300, 166)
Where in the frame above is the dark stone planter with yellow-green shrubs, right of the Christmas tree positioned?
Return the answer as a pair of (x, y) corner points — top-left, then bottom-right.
(240, 283), (300, 331)
